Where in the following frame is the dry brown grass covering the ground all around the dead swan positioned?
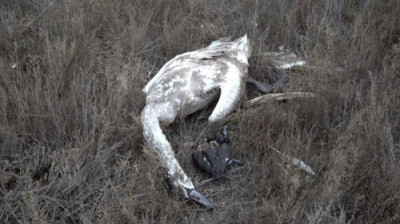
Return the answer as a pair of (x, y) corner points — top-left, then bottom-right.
(0, 0), (400, 223)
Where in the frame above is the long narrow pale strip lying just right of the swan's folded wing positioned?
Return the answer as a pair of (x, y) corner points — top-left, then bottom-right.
(247, 92), (315, 106)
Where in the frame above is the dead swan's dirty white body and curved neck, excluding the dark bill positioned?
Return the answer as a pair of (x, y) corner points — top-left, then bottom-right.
(141, 35), (251, 205)
